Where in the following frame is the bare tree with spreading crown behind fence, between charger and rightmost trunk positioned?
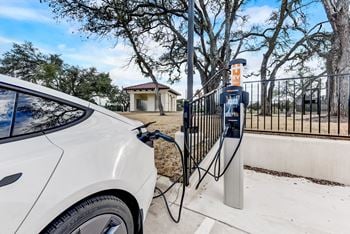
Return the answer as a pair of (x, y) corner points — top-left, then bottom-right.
(235, 0), (330, 115)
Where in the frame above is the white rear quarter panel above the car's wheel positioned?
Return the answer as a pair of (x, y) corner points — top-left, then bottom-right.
(18, 112), (155, 233)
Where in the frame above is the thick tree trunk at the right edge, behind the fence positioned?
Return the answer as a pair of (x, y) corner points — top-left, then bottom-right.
(322, 0), (350, 116)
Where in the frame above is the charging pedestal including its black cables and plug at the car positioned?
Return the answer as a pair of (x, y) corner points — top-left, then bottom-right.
(146, 59), (249, 223)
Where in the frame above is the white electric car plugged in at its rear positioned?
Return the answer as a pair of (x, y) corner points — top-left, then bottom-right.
(0, 75), (157, 234)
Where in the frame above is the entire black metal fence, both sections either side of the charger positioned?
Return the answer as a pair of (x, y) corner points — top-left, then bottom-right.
(183, 74), (350, 184)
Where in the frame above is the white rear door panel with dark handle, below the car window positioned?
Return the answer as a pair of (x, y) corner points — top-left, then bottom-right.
(0, 136), (62, 233)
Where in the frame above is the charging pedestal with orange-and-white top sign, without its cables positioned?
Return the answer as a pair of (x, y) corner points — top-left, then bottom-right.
(220, 59), (249, 209)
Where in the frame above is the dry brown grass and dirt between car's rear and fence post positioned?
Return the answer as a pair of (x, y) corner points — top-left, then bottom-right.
(118, 112), (182, 180)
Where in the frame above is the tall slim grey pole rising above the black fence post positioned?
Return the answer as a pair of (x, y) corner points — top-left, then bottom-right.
(187, 0), (194, 99)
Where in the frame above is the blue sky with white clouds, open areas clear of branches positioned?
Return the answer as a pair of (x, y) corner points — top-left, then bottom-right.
(0, 0), (326, 97)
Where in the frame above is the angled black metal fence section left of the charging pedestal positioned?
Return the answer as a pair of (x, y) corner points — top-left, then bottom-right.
(183, 89), (222, 184)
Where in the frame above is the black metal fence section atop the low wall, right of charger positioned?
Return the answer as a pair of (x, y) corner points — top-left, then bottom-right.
(243, 75), (350, 138)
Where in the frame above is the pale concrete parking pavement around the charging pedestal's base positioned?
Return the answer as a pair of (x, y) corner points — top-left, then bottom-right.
(145, 170), (350, 234)
